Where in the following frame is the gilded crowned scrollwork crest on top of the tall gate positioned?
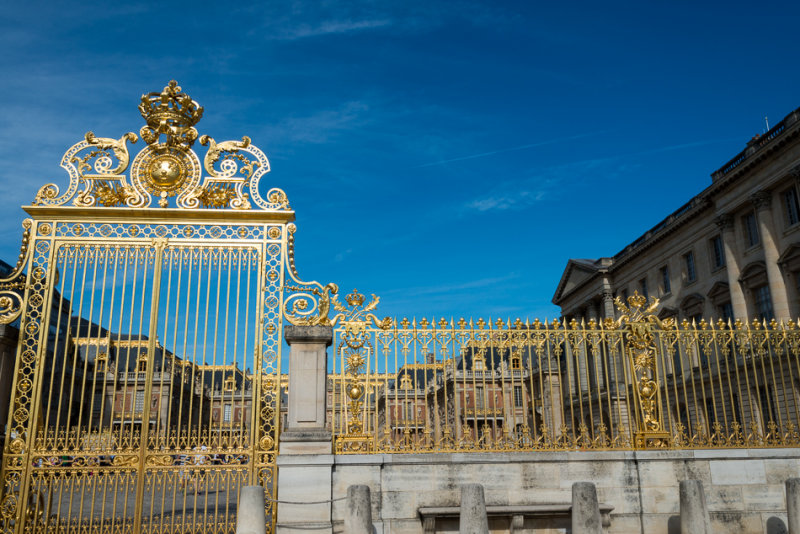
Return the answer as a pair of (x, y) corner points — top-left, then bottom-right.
(34, 80), (291, 211)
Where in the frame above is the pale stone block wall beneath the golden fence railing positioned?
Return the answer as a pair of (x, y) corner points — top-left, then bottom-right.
(332, 449), (800, 534)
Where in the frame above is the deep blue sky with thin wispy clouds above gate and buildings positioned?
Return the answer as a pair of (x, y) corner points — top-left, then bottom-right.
(0, 0), (800, 319)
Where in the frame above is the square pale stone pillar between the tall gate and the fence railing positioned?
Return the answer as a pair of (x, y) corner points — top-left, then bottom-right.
(275, 326), (333, 534)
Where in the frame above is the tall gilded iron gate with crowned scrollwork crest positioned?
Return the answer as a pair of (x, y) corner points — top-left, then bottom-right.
(0, 82), (328, 533)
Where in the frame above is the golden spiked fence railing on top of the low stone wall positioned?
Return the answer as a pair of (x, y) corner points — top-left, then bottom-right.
(331, 295), (800, 453)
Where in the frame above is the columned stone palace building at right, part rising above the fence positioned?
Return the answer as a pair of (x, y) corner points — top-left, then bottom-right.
(552, 103), (800, 321)
